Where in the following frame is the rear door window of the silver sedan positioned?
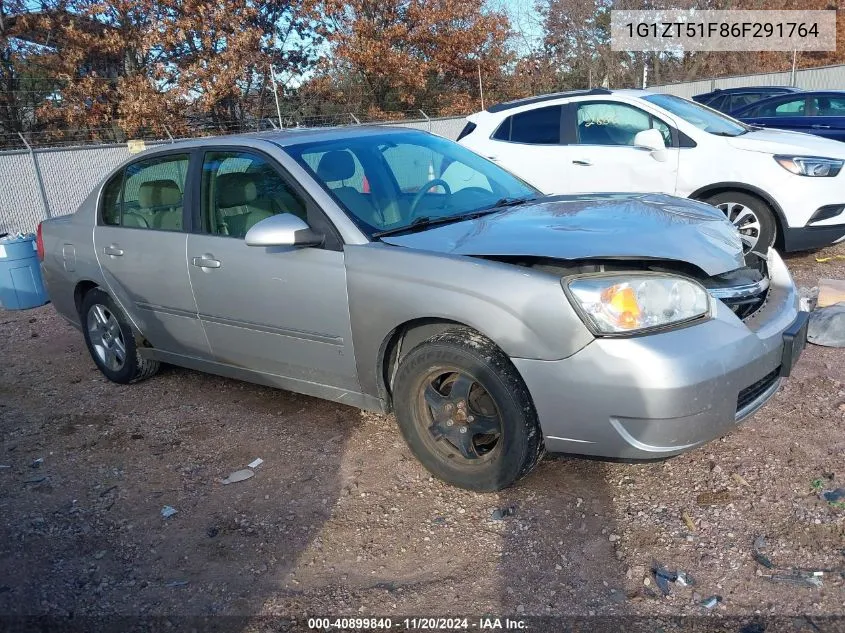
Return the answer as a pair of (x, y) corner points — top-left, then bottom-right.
(101, 154), (188, 231)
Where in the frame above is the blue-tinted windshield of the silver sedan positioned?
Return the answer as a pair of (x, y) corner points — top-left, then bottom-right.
(285, 130), (539, 237)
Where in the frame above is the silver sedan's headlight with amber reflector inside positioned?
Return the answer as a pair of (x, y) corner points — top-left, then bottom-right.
(564, 273), (710, 334)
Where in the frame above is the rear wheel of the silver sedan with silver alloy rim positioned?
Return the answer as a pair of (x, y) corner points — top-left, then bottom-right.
(79, 288), (159, 385)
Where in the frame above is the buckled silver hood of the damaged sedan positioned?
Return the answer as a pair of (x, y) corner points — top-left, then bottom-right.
(381, 194), (745, 276)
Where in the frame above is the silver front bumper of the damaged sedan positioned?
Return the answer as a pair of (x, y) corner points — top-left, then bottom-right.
(513, 250), (798, 459)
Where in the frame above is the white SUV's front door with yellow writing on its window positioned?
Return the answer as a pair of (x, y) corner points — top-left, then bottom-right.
(560, 100), (679, 194)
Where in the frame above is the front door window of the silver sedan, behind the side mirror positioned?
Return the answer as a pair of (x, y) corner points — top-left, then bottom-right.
(200, 152), (308, 238)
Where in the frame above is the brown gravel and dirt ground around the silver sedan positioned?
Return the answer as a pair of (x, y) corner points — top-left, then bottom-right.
(0, 246), (845, 630)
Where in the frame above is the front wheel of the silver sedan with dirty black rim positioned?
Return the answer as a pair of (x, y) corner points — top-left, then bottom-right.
(393, 327), (545, 492)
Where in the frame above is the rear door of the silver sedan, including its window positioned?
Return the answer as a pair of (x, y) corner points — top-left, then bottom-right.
(94, 152), (209, 358)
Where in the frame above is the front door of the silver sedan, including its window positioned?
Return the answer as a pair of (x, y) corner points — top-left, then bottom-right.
(187, 150), (360, 393)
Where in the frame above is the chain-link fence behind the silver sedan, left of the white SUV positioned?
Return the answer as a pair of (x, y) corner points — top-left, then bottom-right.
(0, 116), (465, 235)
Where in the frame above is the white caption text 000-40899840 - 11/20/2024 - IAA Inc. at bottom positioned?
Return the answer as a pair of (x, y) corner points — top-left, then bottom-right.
(308, 616), (528, 631)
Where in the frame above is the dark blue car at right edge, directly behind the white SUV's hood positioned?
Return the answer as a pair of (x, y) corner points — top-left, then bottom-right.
(731, 90), (845, 141)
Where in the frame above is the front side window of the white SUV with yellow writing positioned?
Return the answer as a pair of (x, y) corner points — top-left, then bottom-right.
(577, 103), (672, 147)
